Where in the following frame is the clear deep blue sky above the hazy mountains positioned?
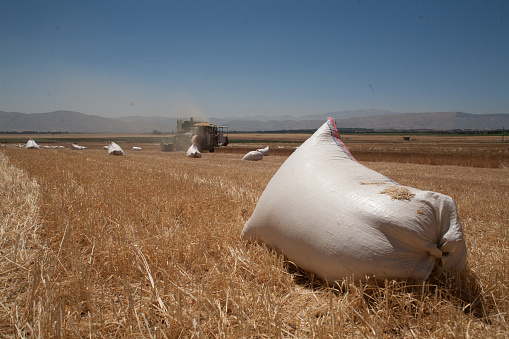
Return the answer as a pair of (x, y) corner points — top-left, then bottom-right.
(0, 0), (509, 117)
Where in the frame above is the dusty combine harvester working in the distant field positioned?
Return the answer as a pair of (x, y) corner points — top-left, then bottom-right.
(161, 118), (228, 153)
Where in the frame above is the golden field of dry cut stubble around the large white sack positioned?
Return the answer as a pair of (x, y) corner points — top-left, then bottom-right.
(0, 135), (509, 338)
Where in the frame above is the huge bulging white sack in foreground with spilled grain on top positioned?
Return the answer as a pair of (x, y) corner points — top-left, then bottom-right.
(242, 118), (467, 283)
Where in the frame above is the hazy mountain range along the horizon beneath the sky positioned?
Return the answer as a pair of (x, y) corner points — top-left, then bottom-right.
(0, 109), (509, 133)
